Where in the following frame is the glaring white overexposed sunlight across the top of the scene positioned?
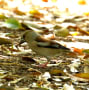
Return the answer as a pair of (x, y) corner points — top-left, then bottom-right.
(0, 0), (89, 16)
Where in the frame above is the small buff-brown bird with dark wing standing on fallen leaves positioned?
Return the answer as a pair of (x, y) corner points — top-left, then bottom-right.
(20, 30), (70, 66)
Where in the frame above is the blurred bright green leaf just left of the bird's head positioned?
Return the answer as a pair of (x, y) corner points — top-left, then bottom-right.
(4, 18), (22, 29)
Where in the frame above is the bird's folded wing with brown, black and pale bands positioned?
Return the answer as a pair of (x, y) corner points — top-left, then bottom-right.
(36, 37), (69, 50)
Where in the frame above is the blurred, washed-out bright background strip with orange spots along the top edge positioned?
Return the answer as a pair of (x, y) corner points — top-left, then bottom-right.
(0, 0), (89, 16)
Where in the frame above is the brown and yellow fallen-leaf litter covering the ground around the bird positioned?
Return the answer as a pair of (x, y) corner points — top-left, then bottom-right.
(0, 0), (89, 90)
